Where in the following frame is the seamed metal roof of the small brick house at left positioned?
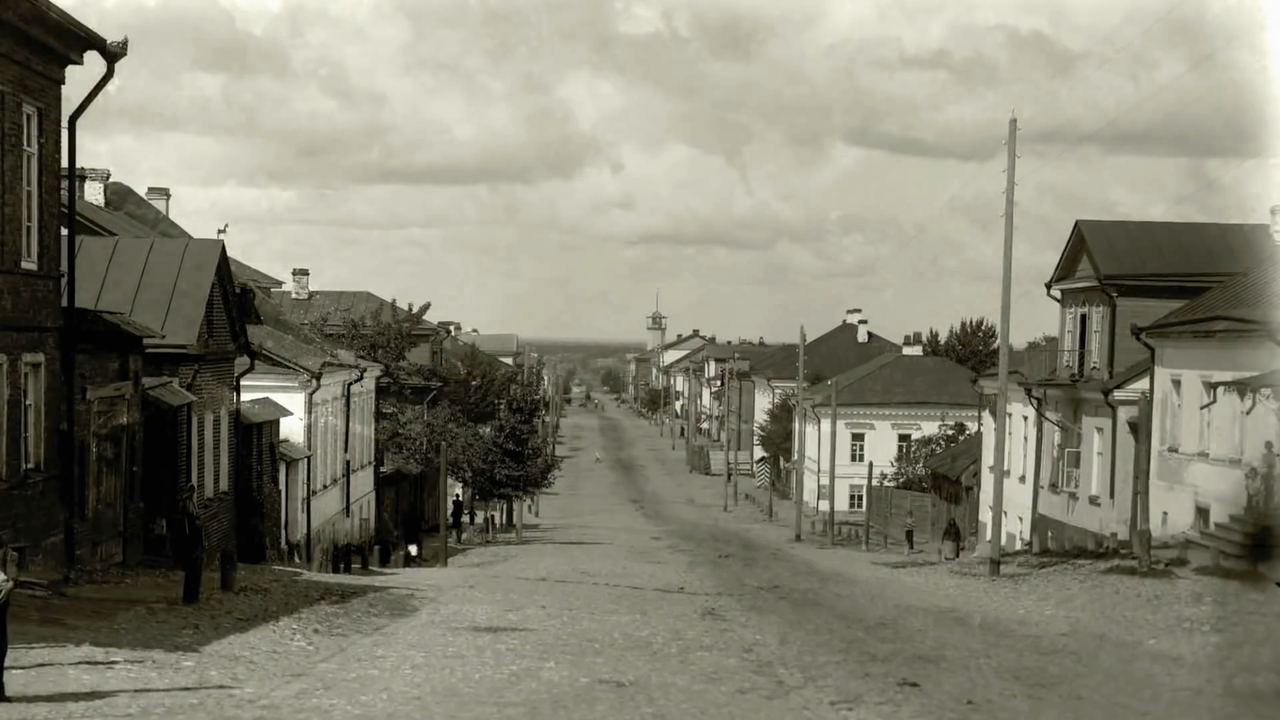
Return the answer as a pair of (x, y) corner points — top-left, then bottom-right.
(63, 236), (234, 348)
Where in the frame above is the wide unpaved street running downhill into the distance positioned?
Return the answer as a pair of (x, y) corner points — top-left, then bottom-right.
(0, 407), (1277, 720)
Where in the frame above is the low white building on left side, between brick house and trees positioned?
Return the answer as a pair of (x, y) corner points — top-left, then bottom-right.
(241, 300), (381, 566)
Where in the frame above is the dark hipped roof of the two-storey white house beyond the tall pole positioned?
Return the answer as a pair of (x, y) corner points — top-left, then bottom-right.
(809, 354), (978, 409)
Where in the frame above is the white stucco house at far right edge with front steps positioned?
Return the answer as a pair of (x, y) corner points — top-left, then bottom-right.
(1139, 260), (1280, 555)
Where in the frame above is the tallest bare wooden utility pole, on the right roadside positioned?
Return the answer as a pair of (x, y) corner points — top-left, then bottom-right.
(987, 114), (1018, 578)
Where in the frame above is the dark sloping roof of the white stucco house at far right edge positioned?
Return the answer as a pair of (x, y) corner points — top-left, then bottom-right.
(1142, 254), (1280, 334)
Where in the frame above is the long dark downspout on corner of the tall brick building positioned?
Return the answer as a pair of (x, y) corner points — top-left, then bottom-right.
(61, 38), (129, 582)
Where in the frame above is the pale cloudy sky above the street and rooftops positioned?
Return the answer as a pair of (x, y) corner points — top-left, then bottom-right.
(60, 0), (1280, 341)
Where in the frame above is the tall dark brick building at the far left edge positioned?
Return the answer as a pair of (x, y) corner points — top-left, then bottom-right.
(0, 0), (124, 566)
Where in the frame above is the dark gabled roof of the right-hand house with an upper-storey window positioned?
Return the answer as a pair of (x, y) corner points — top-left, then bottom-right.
(1046, 220), (1274, 286)
